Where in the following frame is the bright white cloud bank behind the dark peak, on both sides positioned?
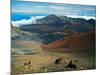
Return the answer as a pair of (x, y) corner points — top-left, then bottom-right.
(12, 15), (95, 27)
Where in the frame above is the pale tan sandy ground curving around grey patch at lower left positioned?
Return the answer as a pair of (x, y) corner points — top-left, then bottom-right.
(12, 41), (56, 64)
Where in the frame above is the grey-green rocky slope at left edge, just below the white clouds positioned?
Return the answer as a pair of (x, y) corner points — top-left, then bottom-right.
(11, 24), (35, 40)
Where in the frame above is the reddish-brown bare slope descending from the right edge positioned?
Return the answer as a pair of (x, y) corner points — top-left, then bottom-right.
(42, 31), (95, 49)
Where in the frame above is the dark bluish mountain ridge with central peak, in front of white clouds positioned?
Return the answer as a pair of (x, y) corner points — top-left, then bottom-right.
(19, 14), (96, 33)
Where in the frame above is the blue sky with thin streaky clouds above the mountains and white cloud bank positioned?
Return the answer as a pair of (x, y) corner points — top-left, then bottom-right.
(12, 0), (96, 17)
